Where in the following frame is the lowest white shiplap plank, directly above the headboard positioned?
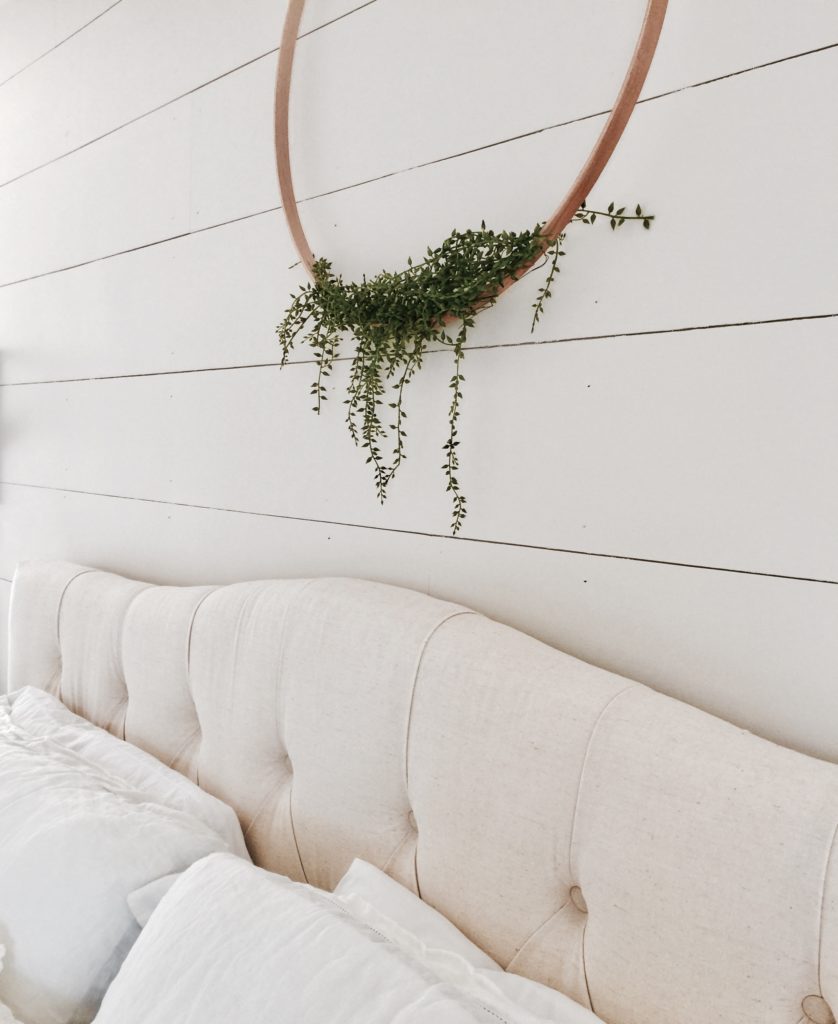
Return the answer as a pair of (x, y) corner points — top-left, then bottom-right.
(0, 485), (838, 761)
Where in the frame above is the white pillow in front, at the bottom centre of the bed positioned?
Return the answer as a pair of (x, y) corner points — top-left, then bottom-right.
(95, 854), (595, 1024)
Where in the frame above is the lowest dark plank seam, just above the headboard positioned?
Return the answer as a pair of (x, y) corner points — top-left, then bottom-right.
(0, 480), (838, 586)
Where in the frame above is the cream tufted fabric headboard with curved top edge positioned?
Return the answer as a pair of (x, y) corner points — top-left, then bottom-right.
(9, 562), (838, 1024)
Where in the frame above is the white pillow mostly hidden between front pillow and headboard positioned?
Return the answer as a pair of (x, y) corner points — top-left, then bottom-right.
(334, 858), (599, 1024)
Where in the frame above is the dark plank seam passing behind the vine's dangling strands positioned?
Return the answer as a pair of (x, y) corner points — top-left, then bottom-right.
(0, 312), (838, 388)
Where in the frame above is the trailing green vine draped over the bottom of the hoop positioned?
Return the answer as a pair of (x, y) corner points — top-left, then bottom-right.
(277, 203), (654, 534)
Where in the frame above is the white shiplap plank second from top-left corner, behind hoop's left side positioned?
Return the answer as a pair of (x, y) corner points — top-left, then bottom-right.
(0, 0), (372, 183)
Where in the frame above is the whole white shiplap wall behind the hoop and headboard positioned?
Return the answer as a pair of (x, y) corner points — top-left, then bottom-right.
(0, 0), (838, 760)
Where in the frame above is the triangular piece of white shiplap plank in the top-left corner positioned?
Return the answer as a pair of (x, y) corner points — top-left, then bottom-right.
(0, 0), (115, 83)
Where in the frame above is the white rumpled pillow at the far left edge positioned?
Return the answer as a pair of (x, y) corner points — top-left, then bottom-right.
(0, 689), (245, 1024)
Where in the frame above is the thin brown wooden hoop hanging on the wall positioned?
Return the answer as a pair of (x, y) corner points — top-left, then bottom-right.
(275, 0), (668, 323)
